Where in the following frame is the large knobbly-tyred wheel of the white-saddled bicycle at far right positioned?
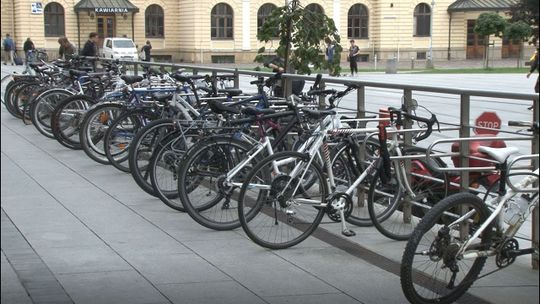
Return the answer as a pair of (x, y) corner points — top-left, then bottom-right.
(401, 193), (493, 304)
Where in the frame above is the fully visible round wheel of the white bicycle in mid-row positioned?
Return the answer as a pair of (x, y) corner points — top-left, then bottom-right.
(238, 152), (328, 249)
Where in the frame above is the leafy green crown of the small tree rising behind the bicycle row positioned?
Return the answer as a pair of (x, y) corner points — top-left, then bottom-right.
(255, 0), (343, 74)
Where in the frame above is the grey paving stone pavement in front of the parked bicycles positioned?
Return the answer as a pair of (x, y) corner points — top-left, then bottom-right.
(1, 64), (539, 304)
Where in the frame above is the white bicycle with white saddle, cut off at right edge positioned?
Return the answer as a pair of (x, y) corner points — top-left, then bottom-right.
(401, 121), (539, 303)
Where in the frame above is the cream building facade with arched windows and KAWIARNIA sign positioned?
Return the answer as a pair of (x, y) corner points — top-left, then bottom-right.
(1, 0), (532, 63)
